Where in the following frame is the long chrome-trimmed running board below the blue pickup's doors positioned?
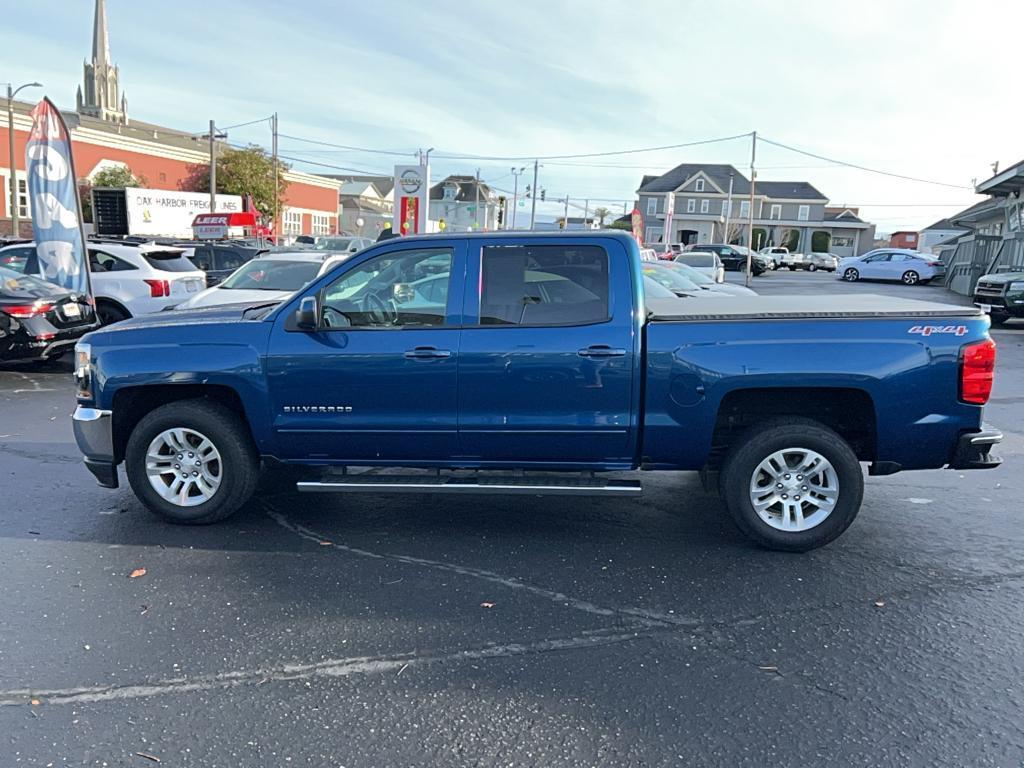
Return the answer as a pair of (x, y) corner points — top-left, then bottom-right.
(295, 473), (643, 496)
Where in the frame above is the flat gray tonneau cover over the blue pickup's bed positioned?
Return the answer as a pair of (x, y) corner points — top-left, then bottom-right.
(646, 294), (982, 323)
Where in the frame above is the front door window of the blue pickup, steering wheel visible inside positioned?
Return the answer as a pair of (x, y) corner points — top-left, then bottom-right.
(324, 248), (452, 328)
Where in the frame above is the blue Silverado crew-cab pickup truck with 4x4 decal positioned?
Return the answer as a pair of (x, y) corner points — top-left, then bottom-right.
(74, 230), (1001, 551)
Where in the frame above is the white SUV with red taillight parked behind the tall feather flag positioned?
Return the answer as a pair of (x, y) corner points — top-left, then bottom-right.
(0, 242), (206, 326)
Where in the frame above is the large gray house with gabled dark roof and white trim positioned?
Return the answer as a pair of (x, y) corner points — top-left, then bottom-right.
(637, 163), (874, 256)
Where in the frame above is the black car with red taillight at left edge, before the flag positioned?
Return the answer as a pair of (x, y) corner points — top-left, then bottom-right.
(0, 266), (98, 361)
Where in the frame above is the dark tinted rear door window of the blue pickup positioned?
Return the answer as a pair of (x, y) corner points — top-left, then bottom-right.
(480, 246), (609, 326)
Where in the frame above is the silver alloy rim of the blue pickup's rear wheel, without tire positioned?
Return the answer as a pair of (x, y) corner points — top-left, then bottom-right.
(750, 447), (839, 532)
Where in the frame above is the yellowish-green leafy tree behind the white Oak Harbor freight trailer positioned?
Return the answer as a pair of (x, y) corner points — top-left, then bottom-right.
(181, 145), (289, 216)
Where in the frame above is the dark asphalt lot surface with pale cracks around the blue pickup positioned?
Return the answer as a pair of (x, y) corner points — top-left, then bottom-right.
(0, 272), (1024, 768)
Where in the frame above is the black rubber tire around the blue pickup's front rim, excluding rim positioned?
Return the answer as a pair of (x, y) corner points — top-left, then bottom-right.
(125, 399), (259, 525)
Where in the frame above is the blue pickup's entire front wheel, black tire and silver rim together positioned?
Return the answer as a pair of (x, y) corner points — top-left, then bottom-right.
(125, 399), (259, 525)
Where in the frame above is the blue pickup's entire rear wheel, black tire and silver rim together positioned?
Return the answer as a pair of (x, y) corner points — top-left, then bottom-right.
(720, 419), (864, 552)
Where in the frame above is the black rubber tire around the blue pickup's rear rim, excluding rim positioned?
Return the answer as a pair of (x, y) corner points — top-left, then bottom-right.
(720, 419), (864, 552)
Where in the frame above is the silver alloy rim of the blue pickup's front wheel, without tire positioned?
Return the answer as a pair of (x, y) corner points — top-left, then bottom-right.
(145, 427), (224, 507)
